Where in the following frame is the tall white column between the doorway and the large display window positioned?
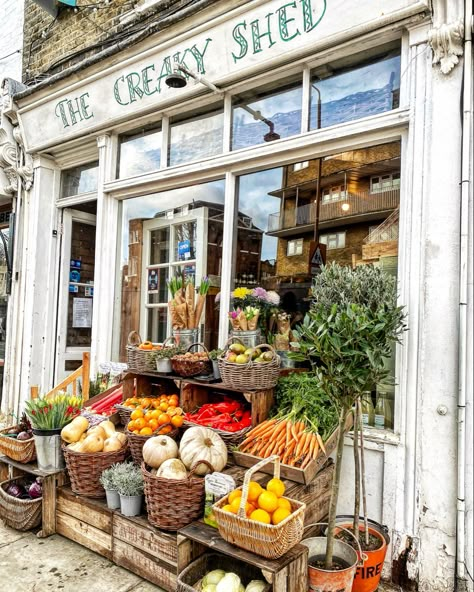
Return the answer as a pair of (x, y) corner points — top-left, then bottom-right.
(91, 135), (118, 373)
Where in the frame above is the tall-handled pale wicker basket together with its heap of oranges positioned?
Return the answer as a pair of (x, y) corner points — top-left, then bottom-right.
(213, 455), (306, 559)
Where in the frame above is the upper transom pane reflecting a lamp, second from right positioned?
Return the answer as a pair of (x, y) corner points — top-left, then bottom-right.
(232, 80), (302, 150)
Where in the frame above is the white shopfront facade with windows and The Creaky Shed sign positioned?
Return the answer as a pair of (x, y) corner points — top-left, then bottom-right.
(2, 0), (472, 591)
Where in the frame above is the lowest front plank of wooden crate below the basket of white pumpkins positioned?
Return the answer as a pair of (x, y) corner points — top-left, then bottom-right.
(113, 538), (178, 592)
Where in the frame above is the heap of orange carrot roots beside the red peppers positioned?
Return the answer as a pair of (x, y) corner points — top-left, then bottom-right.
(239, 417), (326, 469)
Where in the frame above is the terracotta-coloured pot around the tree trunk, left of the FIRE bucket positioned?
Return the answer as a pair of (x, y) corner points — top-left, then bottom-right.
(301, 537), (359, 592)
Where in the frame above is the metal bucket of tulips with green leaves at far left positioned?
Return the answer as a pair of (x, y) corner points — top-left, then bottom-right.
(25, 392), (82, 471)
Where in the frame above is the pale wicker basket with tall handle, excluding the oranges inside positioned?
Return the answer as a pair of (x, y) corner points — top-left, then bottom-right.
(213, 455), (306, 559)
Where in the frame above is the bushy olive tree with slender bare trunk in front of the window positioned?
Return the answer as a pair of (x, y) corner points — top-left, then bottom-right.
(292, 264), (405, 590)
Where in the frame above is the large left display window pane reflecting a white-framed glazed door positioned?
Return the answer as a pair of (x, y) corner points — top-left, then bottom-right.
(116, 180), (225, 359)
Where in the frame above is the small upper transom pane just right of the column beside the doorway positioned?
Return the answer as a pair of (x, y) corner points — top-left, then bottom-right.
(118, 128), (161, 177)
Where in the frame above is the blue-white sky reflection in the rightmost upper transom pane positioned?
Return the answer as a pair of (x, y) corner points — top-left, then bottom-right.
(311, 56), (400, 105)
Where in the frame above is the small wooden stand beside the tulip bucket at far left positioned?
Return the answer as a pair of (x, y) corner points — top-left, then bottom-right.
(0, 456), (67, 538)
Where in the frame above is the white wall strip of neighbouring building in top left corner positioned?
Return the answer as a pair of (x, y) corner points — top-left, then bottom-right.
(0, 0), (23, 81)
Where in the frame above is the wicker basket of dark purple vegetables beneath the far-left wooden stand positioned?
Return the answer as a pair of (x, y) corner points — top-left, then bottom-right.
(0, 477), (43, 531)
